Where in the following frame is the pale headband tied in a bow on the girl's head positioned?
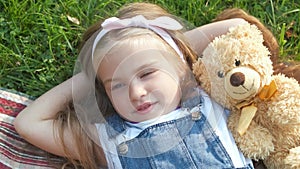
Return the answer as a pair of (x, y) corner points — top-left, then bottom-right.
(92, 15), (184, 61)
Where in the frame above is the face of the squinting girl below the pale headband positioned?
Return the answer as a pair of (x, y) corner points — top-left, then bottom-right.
(97, 40), (181, 122)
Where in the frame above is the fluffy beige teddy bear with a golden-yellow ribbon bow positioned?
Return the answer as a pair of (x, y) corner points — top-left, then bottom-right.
(192, 23), (300, 169)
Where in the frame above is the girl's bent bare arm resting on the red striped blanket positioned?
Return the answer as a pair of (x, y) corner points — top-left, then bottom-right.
(14, 73), (88, 159)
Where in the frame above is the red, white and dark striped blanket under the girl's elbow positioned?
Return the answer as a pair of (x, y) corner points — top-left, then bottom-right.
(0, 89), (59, 169)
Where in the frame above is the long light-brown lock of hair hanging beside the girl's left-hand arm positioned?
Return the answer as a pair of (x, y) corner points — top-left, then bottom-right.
(53, 102), (106, 169)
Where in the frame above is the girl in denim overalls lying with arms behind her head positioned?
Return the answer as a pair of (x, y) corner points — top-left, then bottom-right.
(14, 3), (253, 168)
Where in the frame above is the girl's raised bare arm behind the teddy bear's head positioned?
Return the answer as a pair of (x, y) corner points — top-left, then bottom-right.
(184, 18), (246, 56)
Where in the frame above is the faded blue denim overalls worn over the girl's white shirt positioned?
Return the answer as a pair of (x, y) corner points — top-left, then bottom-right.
(99, 89), (252, 169)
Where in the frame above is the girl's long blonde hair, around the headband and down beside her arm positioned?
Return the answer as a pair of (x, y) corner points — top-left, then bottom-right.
(54, 3), (196, 169)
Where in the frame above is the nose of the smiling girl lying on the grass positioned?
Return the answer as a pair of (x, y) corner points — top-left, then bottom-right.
(129, 80), (147, 100)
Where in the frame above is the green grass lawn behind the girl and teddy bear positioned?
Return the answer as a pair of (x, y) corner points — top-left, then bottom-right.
(0, 0), (300, 97)
